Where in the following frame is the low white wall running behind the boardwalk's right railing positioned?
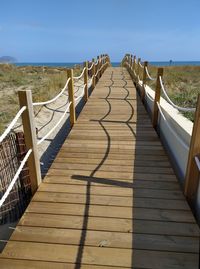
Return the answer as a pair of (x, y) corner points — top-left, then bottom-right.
(139, 84), (200, 220)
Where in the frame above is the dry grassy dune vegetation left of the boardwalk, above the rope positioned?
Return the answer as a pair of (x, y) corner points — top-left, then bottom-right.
(0, 64), (82, 133)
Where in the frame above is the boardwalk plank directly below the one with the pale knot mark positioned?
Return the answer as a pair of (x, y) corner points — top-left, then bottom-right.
(2, 242), (198, 269)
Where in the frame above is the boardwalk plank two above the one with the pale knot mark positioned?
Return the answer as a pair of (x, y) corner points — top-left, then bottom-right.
(26, 202), (195, 223)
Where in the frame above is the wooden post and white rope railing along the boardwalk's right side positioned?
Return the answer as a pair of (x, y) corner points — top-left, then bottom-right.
(122, 54), (200, 208)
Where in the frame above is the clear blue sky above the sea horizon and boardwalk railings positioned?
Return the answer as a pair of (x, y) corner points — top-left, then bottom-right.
(0, 0), (200, 62)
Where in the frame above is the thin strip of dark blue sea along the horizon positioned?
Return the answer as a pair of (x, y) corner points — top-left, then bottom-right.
(15, 61), (200, 68)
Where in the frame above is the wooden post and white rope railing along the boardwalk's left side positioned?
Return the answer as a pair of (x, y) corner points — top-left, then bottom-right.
(0, 54), (110, 208)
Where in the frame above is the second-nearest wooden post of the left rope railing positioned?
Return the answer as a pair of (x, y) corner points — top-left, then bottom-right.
(67, 69), (76, 127)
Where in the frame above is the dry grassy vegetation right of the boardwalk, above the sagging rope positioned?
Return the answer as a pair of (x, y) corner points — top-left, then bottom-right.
(148, 66), (200, 121)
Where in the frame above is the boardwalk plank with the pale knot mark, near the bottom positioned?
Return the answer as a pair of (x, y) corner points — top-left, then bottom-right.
(11, 226), (198, 253)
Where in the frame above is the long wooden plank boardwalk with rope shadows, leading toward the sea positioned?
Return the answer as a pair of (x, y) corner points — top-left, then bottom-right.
(0, 68), (199, 269)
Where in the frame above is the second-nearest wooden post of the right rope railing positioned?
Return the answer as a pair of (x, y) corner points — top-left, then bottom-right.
(152, 68), (163, 128)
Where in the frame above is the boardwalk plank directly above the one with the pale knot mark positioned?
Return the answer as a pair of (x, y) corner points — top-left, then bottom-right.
(18, 213), (199, 238)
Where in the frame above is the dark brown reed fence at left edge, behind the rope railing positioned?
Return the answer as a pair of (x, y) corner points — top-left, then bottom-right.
(0, 132), (31, 224)
